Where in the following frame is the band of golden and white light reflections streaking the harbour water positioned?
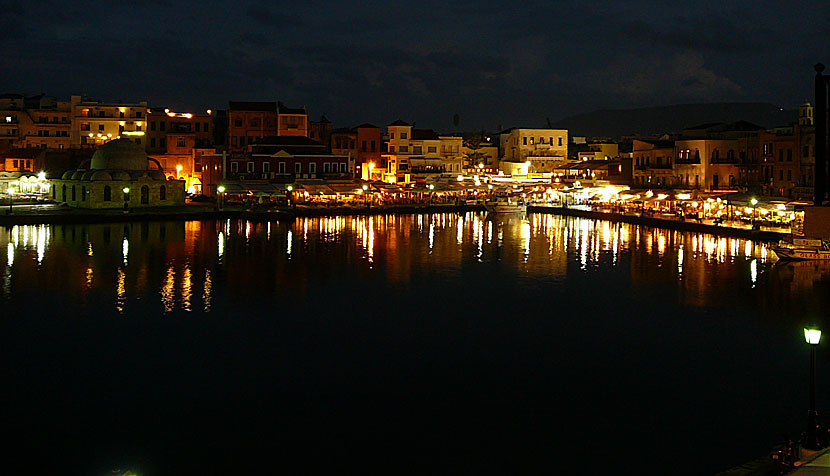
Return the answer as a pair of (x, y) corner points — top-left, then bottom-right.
(0, 213), (830, 313)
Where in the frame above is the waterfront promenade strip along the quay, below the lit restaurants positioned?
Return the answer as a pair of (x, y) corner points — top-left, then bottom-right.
(0, 203), (790, 242)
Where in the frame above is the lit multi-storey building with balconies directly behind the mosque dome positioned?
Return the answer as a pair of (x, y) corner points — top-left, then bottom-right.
(70, 96), (147, 148)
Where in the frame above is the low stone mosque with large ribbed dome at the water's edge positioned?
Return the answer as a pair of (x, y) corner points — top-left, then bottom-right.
(52, 139), (184, 209)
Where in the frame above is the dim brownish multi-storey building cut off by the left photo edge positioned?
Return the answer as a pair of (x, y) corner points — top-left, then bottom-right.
(0, 94), (71, 151)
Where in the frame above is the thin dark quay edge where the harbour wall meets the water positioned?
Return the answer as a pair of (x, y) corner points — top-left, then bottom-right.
(0, 204), (789, 242)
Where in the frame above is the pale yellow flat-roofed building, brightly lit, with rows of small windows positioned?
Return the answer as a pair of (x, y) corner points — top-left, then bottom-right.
(499, 128), (568, 173)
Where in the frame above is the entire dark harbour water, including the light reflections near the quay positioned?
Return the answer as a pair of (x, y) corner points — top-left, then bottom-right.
(0, 213), (830, 475)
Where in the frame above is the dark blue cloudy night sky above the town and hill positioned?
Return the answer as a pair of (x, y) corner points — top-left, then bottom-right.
(0, 0), (830, 130)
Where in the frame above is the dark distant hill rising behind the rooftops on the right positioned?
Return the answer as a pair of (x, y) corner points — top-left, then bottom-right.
(553, 103), (798, 139)
